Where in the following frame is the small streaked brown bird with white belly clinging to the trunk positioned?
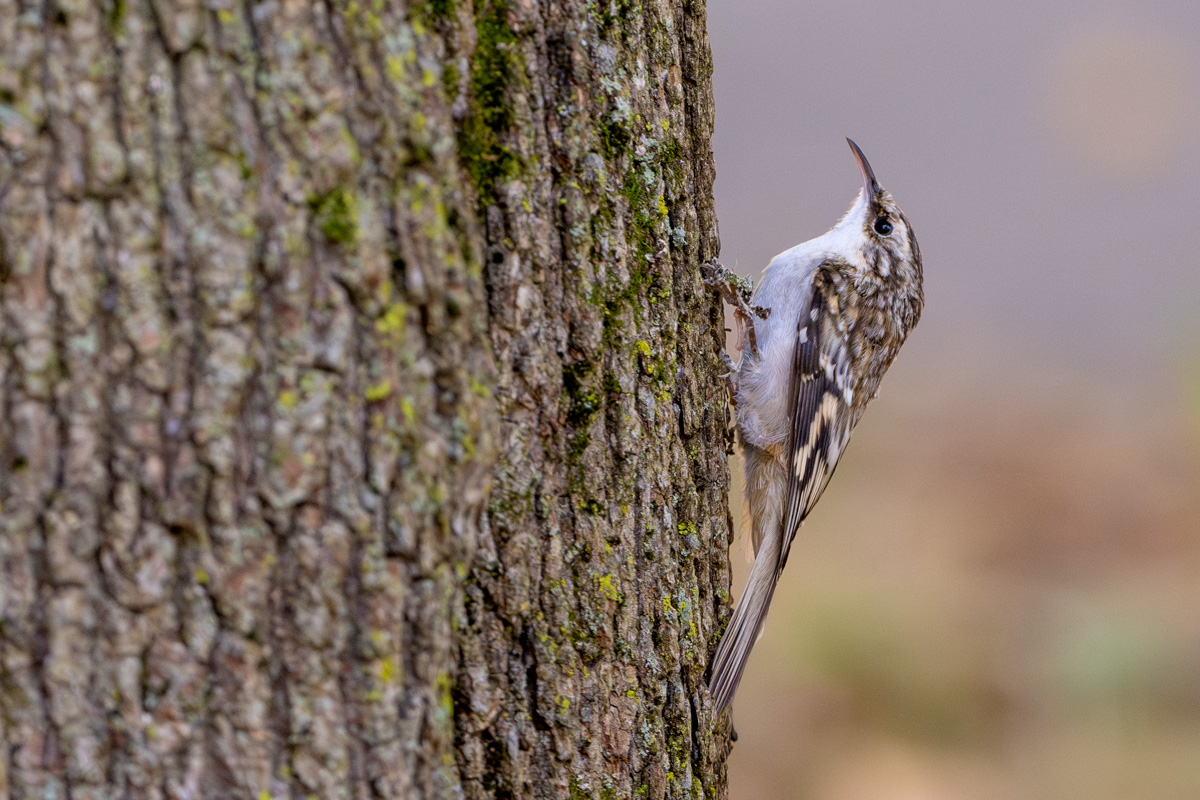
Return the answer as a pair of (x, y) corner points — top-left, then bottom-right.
(708, 138), (924, 712)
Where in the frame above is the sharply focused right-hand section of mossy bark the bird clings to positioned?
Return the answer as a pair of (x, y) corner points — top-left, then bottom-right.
(456, 0), (728, 798)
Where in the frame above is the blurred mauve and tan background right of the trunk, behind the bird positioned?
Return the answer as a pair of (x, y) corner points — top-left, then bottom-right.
(708, 0), (1200, 800)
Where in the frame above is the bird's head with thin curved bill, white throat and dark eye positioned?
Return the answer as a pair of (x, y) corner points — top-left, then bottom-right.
(827, 139), (922, 283)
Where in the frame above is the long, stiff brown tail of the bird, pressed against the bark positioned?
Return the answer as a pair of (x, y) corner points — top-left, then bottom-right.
(708, 533), (780, 712)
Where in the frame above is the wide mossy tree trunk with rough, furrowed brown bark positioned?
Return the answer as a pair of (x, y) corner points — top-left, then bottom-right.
(0, 0), (730, 800)
